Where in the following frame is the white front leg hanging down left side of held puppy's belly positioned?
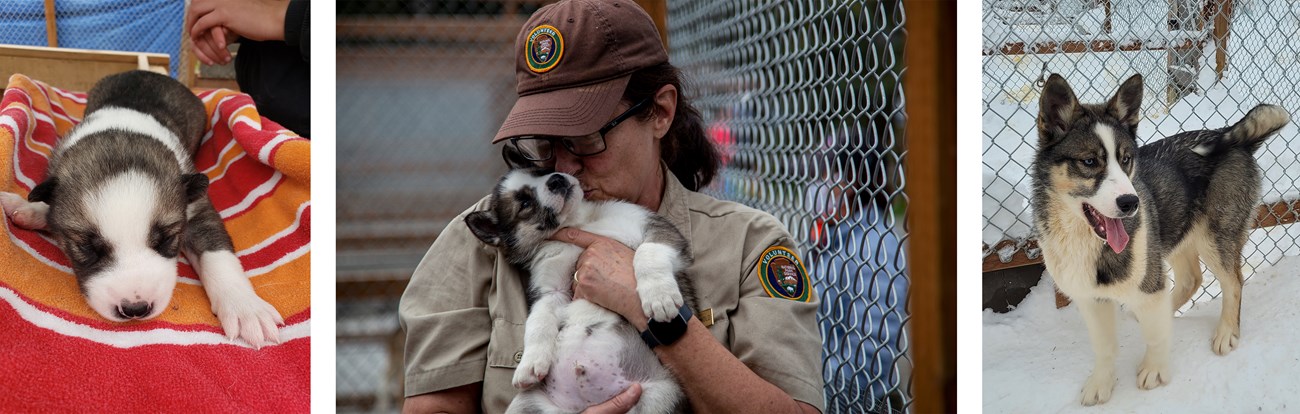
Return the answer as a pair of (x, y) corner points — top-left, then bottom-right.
(511, 242), (582, 389)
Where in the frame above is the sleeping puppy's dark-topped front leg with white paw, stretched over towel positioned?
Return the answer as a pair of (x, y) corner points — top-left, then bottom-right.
(182, 195), (285, 348)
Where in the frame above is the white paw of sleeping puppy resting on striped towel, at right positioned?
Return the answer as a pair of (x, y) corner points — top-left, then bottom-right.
(212, 292), (285, 349)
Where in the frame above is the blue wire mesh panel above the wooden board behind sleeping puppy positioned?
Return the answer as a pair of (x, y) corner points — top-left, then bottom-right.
(0, 0), (185, 77)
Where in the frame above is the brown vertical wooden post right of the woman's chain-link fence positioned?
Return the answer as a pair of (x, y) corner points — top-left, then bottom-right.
(902, 0), (957, 413)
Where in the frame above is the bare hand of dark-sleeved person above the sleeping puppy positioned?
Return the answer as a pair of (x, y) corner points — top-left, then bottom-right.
(185, 0), (289, 65)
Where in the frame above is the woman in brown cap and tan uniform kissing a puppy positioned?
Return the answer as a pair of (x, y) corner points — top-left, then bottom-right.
(399, 1), (823, 413)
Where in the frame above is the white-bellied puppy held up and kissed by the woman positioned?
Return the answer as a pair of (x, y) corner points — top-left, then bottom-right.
(465, 169), (696, 413)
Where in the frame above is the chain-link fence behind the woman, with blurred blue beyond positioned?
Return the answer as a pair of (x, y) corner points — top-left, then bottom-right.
(668, 1), (913, 413)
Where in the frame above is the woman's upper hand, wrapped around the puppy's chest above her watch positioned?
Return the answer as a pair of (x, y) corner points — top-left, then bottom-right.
(551, 228), (649, 331)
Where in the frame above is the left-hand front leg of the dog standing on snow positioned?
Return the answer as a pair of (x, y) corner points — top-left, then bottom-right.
(1075, 298), (1118, 406)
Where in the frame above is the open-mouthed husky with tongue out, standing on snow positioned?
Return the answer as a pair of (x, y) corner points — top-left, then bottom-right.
(1032, 74), (1290, 405)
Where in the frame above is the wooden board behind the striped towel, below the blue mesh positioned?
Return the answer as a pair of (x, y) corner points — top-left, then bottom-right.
(0, 44), (170, 91)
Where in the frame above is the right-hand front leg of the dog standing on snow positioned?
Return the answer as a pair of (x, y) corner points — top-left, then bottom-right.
(1134, 291), (1174, 389)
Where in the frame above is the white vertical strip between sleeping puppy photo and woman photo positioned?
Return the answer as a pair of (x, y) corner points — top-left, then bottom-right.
(311, 1), (338, 413)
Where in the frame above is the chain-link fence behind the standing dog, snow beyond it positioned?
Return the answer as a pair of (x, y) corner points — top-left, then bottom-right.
(983, 0), (1300, 306)
